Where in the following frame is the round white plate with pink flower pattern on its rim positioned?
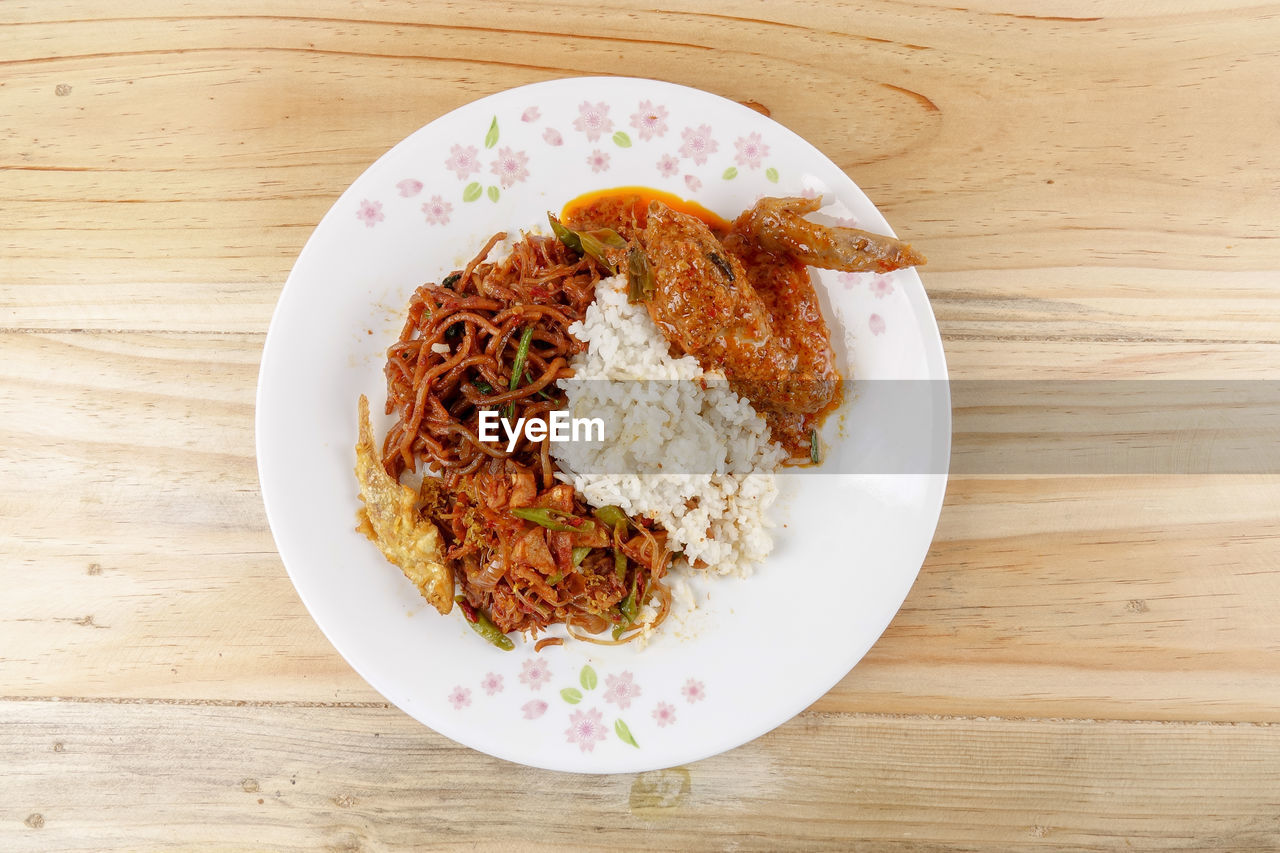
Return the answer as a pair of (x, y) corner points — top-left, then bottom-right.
(257, 78), (950, 772)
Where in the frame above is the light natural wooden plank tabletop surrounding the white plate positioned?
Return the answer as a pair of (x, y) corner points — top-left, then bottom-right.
(0, 0), (1280, 850)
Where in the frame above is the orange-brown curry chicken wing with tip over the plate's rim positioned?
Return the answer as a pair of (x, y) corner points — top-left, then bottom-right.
(634, 199), (924, 456)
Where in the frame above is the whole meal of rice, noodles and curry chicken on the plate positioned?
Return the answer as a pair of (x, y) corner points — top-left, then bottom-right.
(356, 188), (924, 649)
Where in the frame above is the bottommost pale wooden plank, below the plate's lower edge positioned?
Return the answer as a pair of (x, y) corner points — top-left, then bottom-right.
(0, 702), (1280, 850)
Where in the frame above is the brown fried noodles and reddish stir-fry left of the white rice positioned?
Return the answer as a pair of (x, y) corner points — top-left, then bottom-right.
(381, 233), (671, 643)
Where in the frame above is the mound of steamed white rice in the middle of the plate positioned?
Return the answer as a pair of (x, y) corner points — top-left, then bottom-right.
(552, 275), (785, 576)
